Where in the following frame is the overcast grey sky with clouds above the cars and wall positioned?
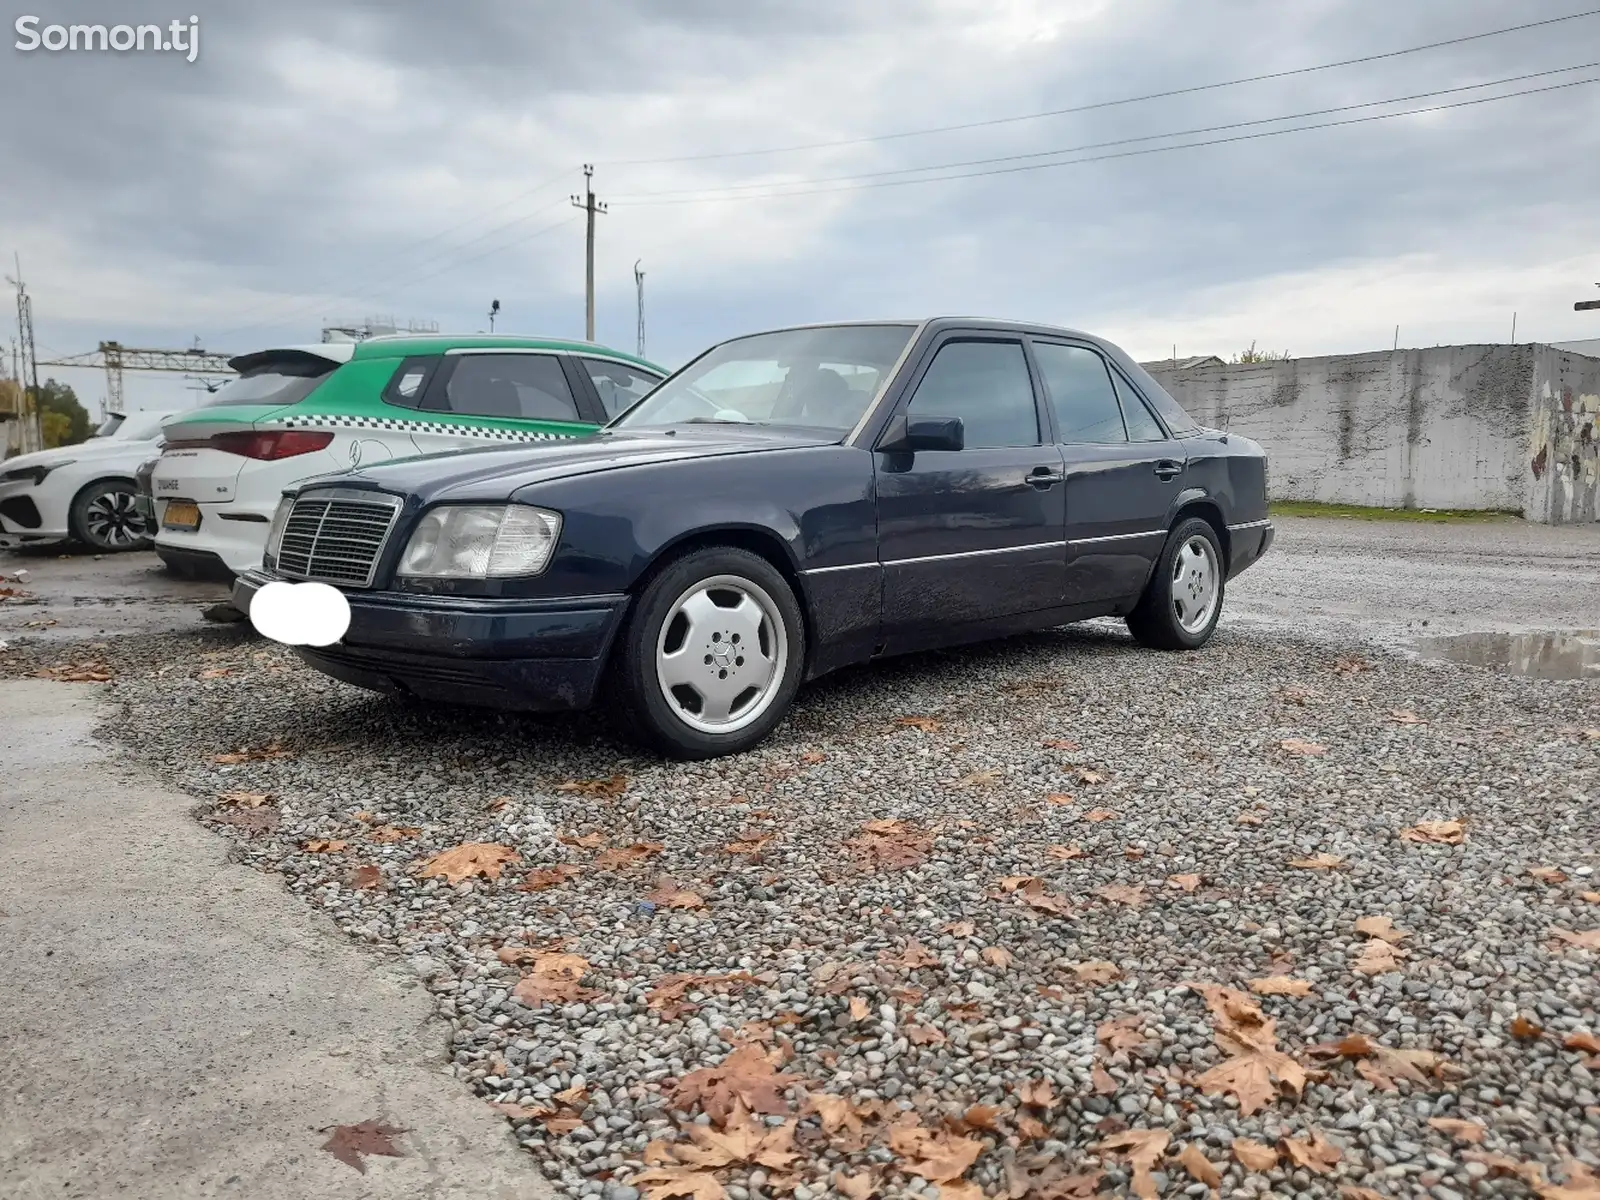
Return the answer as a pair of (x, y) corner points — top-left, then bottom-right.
(0, 0), (1600, 408)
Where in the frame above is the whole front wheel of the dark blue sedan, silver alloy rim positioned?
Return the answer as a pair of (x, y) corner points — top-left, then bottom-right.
(614, 546), (805, 758)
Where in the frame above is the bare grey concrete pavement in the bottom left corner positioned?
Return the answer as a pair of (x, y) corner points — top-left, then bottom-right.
(0, 682), (552, 1200)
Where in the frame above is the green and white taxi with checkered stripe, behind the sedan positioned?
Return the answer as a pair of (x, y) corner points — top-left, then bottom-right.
(150, 334), (667, 576)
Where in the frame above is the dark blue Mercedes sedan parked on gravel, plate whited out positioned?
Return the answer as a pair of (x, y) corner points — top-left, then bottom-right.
(234, 318), (1272, 758)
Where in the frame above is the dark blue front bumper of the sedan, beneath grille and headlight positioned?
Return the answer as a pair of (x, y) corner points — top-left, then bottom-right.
(234, 571), (629, 712)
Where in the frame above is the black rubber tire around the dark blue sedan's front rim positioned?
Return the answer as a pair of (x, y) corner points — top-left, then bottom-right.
(611, 546), (806, 758)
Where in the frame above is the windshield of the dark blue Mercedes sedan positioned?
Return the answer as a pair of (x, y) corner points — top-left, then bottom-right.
(611, 325), (917, 434)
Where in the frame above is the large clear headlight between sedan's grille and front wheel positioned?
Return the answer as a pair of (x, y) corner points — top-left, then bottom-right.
(400, 504), (562, 579)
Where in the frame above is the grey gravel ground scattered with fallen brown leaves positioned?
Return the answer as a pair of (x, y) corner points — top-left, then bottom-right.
(0, 624), (1600, 1200)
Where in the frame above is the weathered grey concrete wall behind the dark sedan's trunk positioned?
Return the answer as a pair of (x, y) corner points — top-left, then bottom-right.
(1146, 344), (1600, 522)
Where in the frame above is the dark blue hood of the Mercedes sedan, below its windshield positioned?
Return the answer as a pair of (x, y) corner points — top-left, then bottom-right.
(304, 424), (838, 501)
